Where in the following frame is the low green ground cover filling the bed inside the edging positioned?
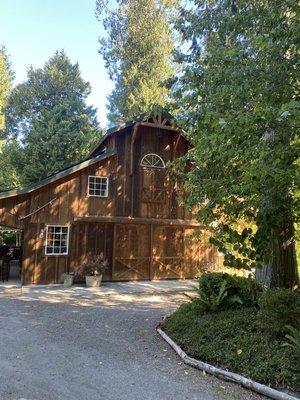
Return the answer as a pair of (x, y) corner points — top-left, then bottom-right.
(164, 301), (298, 388)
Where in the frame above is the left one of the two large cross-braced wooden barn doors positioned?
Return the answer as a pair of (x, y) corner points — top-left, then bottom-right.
(112, 224), (150, 281)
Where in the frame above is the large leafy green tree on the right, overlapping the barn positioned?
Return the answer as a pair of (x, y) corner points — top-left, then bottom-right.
(178, 0), (300, 287)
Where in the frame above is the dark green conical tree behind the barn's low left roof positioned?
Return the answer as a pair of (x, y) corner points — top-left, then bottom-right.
(6, 51), (100, 184)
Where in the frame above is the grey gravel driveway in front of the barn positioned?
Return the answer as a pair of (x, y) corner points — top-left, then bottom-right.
(0, 288), (262, 400)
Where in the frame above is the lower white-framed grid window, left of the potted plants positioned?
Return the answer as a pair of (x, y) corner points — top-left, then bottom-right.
(45, 225), (70, 256)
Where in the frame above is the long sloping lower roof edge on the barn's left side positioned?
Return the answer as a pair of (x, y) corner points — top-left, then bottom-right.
(0, 151), (117, 200)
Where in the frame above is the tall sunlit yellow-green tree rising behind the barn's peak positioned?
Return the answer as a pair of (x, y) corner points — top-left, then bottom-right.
(96, 0), (178, 124)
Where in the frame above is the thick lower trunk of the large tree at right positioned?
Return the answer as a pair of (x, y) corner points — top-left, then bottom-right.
(255, 217), (299, 288)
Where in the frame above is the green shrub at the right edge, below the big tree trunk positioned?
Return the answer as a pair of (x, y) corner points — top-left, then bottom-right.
(258, 289), (300, 335)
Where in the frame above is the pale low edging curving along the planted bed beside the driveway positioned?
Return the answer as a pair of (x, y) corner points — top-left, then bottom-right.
(156, 325), (299, 400)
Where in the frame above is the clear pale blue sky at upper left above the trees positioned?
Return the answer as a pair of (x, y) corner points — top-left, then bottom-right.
(0, 0), (113, 127)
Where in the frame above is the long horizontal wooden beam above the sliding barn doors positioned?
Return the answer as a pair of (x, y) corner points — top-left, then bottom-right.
(74, 215), (202, 227)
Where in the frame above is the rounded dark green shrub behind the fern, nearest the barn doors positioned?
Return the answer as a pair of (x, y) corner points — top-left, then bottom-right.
(199, 272), (263, 309)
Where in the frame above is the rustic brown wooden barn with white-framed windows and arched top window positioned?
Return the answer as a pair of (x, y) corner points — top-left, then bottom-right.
(0, 114), (222, 284)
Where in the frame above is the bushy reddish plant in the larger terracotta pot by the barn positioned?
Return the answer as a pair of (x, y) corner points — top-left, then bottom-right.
(77, 253), (108, 287)
